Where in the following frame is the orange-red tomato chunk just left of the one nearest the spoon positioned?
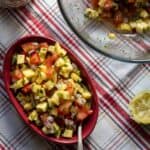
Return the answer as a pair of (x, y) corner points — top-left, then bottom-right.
(58, 101), (72, 115)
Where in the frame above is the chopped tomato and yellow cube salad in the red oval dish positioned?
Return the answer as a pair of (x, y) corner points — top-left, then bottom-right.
(10, 42), (93, 138)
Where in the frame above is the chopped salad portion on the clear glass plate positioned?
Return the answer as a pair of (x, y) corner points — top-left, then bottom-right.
(85, 0), (150, 33)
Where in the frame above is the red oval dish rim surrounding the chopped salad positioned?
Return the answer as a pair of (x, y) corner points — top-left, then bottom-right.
(3, 35), (98, 144)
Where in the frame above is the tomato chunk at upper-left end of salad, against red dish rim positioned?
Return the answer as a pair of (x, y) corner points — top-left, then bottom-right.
(21, 42), (39, 53)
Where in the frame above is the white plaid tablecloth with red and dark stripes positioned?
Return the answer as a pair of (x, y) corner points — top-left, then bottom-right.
(0, 0), (150, 150)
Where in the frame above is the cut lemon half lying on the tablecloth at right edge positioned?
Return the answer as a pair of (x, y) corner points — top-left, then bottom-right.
(129, 90), (150, 124)
